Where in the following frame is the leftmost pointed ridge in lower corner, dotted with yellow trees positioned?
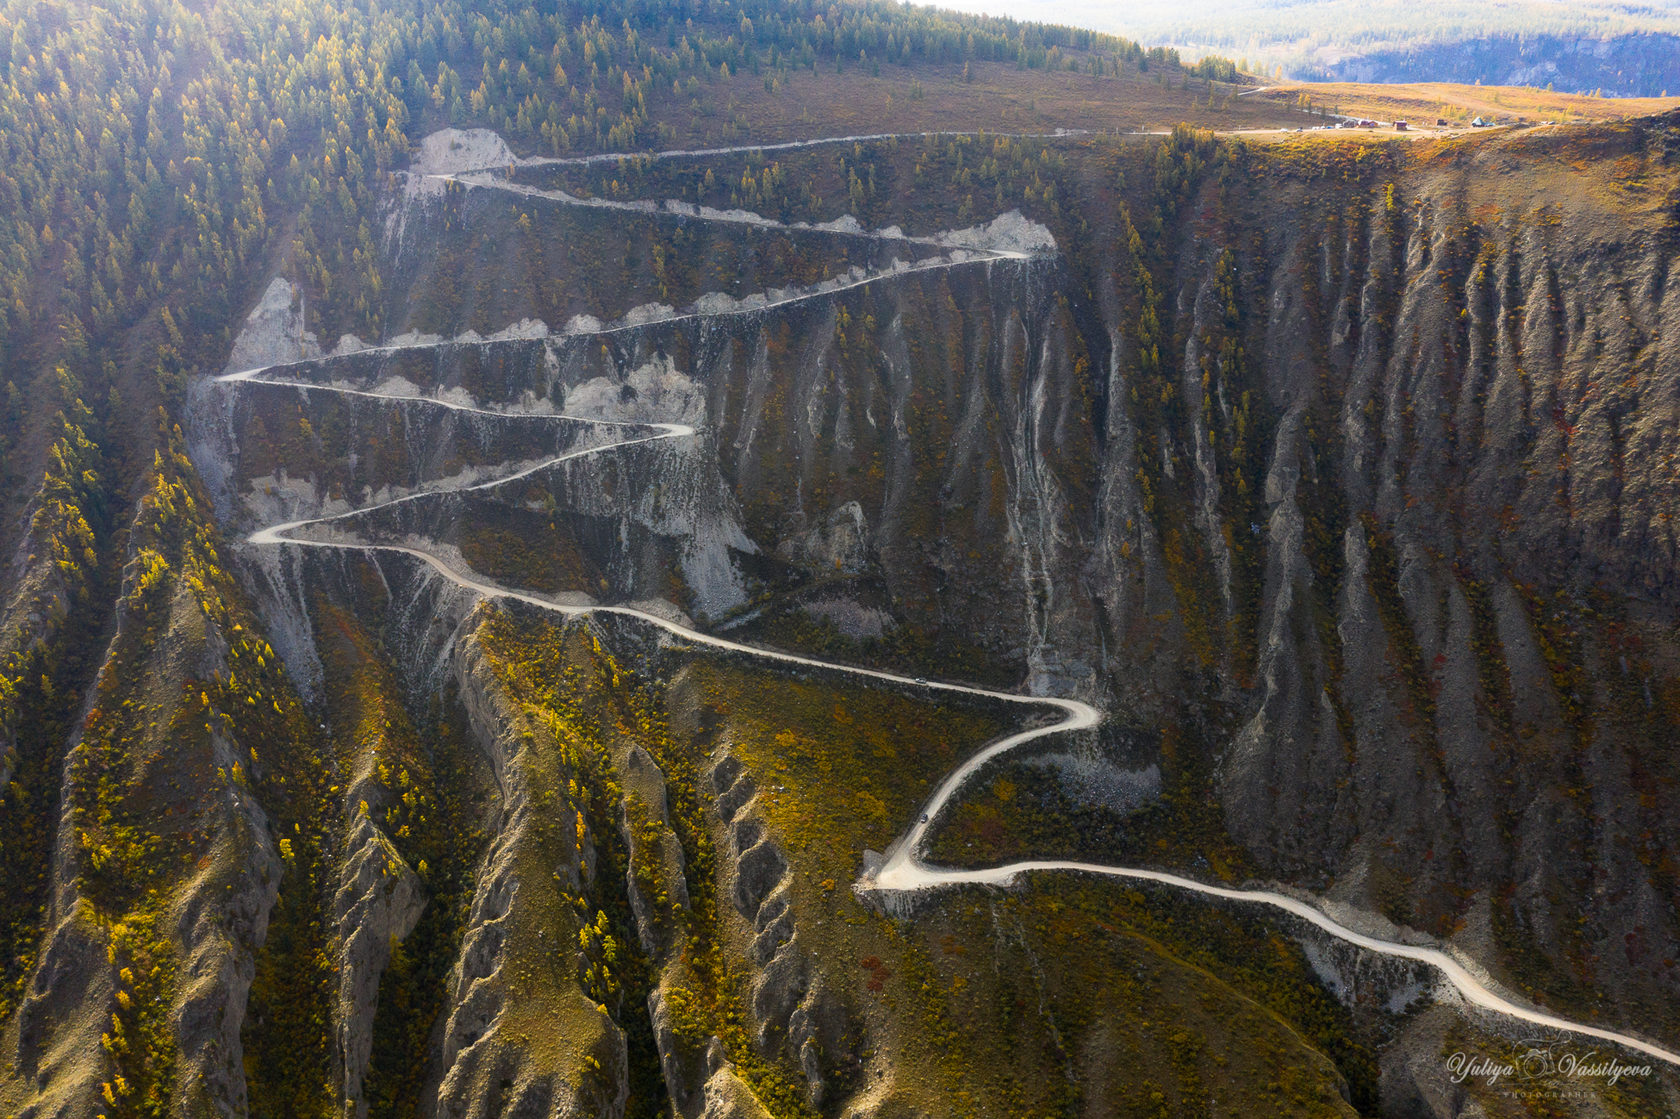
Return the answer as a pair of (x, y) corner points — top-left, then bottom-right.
(0, 450), (301, 1116)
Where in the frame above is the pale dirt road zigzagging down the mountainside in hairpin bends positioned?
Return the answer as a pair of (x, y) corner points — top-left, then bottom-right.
(218, 141), (1680, 1067)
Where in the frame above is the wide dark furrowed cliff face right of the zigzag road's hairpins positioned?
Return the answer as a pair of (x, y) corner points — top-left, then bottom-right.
(551, 124), (1680, 1022)
